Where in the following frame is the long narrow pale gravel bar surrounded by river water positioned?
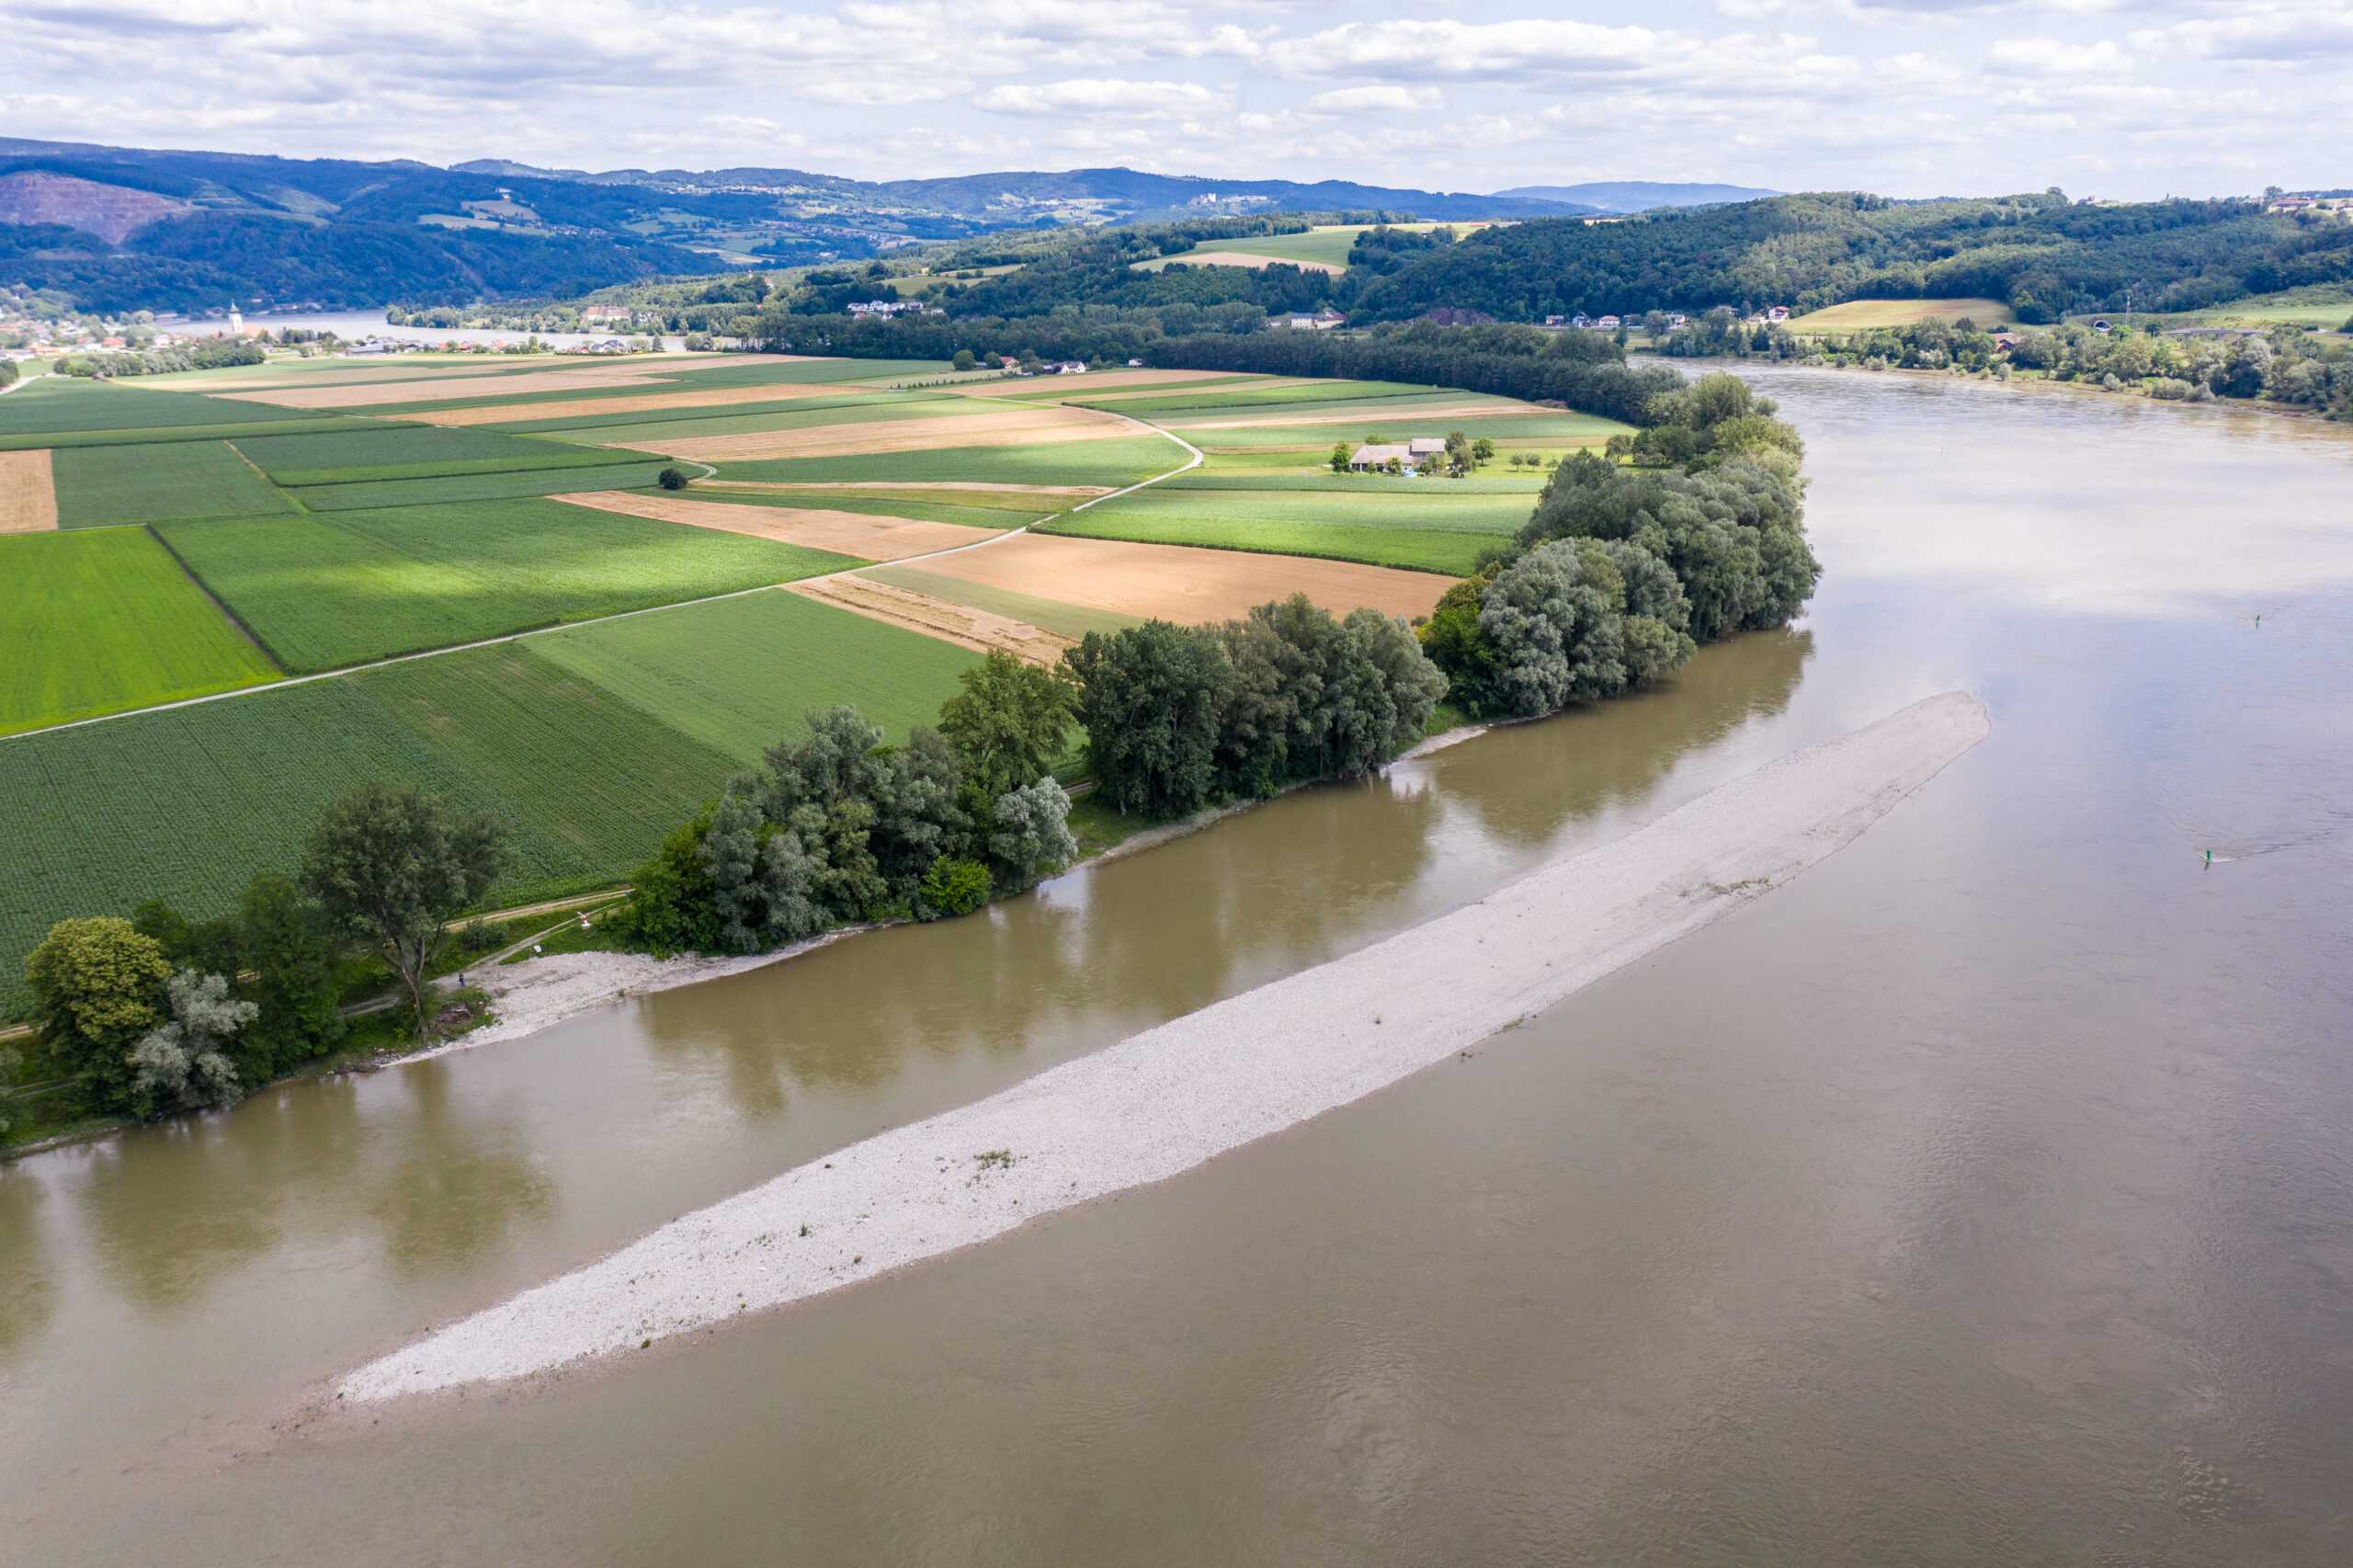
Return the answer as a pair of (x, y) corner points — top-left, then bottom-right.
(336, 692), (1988, 1401)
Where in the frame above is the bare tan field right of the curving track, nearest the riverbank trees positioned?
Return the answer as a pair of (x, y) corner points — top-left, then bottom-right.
(898, 534), (1452, 621)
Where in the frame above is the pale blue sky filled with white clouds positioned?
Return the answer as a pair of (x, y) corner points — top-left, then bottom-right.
(0, 0), (2353, 198)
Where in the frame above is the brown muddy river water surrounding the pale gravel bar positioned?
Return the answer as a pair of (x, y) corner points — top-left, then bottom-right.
(0, 372), (2353, 1568)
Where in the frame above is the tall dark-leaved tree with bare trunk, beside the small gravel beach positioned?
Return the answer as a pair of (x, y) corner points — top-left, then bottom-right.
(301, 784), (511, 1036)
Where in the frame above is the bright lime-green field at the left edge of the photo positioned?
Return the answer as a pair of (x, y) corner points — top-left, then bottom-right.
(0, 528), (278, 734)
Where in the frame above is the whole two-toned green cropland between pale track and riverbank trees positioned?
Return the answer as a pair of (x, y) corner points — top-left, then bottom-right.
(0, 588), (974, 1012)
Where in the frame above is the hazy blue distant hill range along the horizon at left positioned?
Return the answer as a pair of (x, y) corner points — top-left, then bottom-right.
(0, 137), (1600, 311)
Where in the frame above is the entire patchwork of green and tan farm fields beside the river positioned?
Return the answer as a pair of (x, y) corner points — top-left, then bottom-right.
(0, 341), (1581, 1010)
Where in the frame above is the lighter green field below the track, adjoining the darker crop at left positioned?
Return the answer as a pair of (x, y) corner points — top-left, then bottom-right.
(532, 594), (979, 767)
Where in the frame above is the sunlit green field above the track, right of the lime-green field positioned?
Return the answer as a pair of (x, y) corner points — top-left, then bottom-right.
(160, 499), (854, 671)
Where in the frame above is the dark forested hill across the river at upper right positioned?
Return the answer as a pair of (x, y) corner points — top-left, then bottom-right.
(1353, 193), (2353, 323)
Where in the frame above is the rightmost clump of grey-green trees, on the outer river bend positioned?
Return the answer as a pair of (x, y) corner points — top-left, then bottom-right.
(1421, 374), (1821, 718)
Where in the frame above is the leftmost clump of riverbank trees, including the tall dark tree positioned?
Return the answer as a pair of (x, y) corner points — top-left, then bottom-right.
(26, 784), (508, 1119)
